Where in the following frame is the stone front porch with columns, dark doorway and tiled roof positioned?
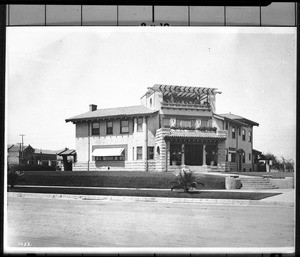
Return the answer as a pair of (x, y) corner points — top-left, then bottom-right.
(164, 129), (225, 173)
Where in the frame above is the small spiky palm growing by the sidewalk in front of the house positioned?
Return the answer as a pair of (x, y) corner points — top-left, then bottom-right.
(171, 169), (202, 193)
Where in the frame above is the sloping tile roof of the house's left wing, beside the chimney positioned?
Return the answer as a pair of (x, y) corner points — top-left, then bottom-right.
(66, 105), (157, 122)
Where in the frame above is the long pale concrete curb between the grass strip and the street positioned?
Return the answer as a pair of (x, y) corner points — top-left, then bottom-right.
(7, 192), (294, 207)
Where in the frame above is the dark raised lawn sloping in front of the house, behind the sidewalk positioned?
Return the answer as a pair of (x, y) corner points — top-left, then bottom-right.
(19, 171), (225, 189)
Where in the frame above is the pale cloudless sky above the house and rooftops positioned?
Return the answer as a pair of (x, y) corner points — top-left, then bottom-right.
(6, 27), (296, 159)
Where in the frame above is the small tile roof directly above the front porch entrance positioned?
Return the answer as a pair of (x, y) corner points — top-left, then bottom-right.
(166, 129), (226, 139)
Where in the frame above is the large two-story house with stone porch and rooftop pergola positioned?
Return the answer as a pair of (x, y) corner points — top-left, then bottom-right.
(66, 84), (258, 172)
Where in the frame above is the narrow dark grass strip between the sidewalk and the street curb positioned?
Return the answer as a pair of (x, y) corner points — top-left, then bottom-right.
(8, 186), (279, 200)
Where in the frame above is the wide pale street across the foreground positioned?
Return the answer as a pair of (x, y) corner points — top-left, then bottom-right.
(7, 197), (295, 247)
